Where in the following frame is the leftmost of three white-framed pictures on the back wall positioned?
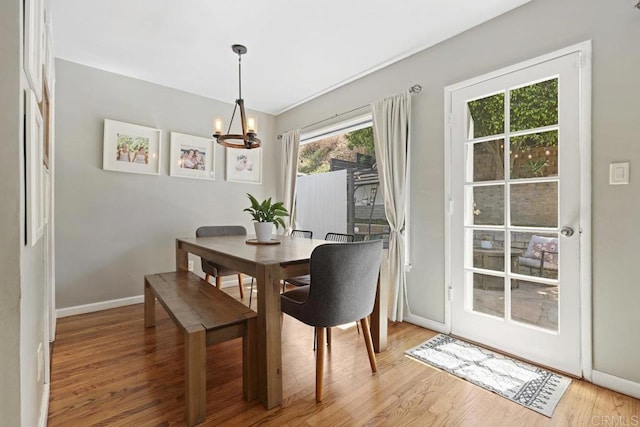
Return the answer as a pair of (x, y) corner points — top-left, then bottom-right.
(102, 119), (160, 175)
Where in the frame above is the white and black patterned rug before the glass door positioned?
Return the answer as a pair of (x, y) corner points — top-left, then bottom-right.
(405, 335), (571, 417)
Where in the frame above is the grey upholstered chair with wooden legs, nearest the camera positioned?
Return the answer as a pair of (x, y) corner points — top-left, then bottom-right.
(280, 240), (382, 402)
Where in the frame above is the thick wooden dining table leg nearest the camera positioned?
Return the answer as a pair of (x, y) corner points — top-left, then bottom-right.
(256, 264), (282, 409)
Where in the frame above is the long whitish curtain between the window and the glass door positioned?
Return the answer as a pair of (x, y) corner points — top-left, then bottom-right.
(371, 91), (411, 322)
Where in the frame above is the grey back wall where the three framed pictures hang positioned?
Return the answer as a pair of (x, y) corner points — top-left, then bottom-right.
(55, 60), (279, 309)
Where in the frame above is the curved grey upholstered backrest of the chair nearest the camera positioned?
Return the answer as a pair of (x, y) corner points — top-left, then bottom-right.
(294, 240), (382, 327)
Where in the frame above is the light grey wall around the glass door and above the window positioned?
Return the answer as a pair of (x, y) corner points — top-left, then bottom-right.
(277, 0), (640, 382)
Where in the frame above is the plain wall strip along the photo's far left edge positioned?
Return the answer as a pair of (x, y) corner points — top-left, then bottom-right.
(0, 0), (22, 426)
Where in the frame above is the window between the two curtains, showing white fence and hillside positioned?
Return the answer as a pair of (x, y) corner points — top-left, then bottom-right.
(296, 115), (389, 246)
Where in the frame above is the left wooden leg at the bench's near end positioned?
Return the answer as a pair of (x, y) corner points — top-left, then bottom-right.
(184, 326), (207, 426)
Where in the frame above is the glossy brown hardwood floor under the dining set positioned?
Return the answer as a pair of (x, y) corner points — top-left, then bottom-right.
(48, 288), (640, 427)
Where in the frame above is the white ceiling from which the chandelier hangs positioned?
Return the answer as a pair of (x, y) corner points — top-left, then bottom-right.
(51, 0), (530, 114)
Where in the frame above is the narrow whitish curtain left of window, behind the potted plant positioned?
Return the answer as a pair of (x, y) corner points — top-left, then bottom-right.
(281, 129), (300, 234)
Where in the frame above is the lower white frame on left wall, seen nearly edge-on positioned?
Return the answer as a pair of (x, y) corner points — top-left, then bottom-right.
(25, 89), (46, 246)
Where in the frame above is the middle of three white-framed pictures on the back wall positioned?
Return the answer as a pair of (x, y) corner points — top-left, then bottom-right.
(169, 132), (215, 180)
